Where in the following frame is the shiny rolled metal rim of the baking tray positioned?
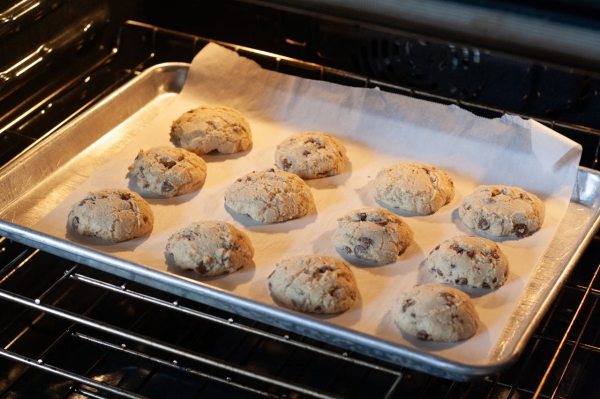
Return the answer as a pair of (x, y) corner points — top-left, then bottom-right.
(0, 62), (600, 381)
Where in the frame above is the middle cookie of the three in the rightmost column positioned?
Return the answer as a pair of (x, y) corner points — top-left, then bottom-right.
(427, 236), (508, 288)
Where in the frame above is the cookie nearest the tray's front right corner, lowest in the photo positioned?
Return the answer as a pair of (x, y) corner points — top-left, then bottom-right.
(392, 284), (479, 342)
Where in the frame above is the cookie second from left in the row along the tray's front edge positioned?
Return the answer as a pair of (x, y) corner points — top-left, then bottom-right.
(165, 221), (254, 277)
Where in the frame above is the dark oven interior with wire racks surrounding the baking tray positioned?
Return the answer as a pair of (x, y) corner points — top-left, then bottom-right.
(0, 0), (600, 398)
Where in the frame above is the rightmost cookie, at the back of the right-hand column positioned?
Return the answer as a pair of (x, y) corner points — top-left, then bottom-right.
(458, 186), (546, 237)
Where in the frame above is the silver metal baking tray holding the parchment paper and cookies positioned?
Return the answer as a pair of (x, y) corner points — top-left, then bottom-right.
(0, 63), (600, 380)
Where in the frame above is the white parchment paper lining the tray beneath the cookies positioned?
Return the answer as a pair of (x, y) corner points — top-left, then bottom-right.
(36, 44), (581, 365)
